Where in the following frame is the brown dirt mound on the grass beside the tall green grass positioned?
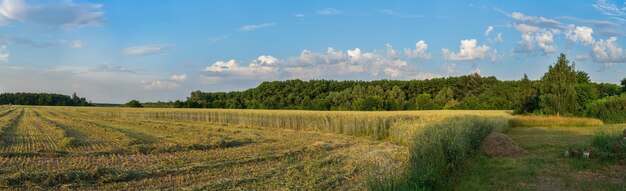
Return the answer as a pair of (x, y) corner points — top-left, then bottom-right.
(480, 133), (528, 157)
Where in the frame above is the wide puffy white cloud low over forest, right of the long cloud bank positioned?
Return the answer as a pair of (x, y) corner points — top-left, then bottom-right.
(442, 39), (490, 61)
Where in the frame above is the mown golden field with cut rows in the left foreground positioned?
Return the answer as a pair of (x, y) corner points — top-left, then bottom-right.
(0, 106), (406, 190)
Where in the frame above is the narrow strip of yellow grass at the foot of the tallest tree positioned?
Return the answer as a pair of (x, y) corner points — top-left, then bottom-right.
(509, 116), (604, 127)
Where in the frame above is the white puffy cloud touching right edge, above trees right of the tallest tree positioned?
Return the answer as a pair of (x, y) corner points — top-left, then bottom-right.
(593, 37), (626, 64)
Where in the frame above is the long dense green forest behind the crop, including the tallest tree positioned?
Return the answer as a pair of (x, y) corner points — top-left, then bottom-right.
(142, 54), (626, 118)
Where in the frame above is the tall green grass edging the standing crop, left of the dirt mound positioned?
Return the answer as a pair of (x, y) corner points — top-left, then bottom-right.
(368, 116), (502, 190)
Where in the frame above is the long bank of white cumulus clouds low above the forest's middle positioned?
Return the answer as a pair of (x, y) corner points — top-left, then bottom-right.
(203, 42), (426, 83)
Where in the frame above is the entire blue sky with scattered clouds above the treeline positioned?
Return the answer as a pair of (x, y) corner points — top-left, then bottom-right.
(0, 0), (626, 103)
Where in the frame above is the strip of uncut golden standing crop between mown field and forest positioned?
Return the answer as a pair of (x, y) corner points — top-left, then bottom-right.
(57, 107), (511, 144)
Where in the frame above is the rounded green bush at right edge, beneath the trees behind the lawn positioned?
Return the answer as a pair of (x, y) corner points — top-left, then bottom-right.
(583, 94), (626, 123)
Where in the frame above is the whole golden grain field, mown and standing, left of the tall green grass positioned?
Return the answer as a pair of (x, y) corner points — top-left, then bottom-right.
(0, 106), (509, 190)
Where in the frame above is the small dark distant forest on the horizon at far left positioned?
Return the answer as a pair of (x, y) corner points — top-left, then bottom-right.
(0, 93), (92, 106)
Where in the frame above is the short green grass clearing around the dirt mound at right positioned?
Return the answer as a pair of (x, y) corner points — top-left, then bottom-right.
(455, 124), (626, 190)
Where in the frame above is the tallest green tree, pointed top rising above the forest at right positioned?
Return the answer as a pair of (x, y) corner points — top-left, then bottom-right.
(539, 53), (578, 115)
